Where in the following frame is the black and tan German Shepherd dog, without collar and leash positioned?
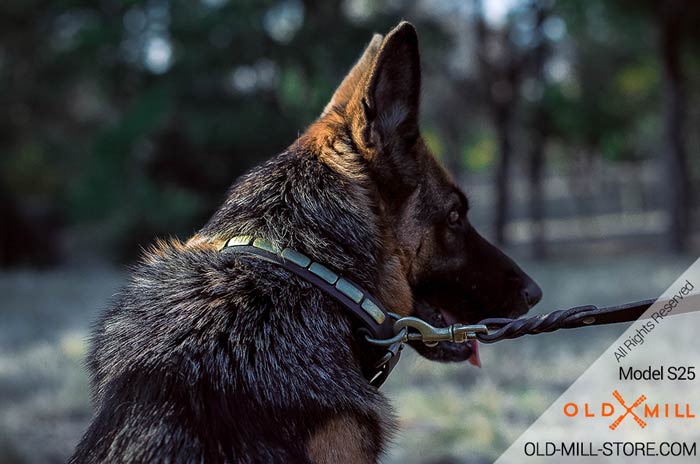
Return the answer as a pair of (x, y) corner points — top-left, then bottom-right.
(71, 22), (541, 463)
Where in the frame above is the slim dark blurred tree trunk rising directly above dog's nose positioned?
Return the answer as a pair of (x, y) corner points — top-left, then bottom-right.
(528, 2), (550, 259)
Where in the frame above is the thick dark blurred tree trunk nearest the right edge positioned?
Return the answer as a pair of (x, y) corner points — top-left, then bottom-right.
(657, 0), (690, 252)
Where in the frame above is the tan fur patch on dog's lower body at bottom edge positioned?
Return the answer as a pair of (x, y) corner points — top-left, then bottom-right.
(307, 416), (375, 464)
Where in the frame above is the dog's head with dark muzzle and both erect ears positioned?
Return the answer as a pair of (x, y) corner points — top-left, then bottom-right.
(324, 22), (542, 361)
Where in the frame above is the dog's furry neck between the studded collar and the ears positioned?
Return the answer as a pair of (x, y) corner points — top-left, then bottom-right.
(188, 117), (413, 315)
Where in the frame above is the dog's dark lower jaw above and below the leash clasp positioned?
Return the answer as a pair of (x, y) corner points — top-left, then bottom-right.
(410, 301), (481, 367)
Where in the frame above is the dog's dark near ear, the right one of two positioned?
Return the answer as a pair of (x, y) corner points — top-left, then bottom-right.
(348, 22), (420, 154)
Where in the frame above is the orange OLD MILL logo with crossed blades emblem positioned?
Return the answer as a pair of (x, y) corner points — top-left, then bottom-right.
(564, 390), (695, 430)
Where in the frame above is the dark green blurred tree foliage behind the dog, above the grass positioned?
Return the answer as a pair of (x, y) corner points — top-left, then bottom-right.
(0, 0), (700, 258)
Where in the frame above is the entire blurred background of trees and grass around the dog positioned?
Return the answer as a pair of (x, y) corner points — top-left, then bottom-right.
(0, 0), (700, 463)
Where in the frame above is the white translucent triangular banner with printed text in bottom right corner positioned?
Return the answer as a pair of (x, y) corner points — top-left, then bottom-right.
(496, 259), (700, 464)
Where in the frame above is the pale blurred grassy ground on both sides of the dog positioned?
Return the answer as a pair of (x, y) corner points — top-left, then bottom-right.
(0, 255), (693, 464)
